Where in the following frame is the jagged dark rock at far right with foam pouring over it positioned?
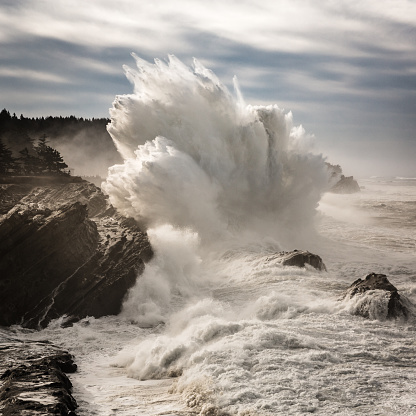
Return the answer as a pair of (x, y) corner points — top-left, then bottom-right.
(343, 273), (411, 319)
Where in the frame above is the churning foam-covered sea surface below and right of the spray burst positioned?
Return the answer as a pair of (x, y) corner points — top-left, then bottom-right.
(10, 178), (416, 415)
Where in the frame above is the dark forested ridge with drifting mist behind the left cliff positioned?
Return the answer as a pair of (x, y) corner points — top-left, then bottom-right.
(0, 109), (119, 175)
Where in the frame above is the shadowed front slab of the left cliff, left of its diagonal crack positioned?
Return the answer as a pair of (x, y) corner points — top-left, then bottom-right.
(0, 202), (99, 327)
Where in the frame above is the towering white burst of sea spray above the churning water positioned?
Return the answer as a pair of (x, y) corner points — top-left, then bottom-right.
(104, 56), (327, 243)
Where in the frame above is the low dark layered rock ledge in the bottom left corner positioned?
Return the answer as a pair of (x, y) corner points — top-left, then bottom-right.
(0, 340), (77, 416)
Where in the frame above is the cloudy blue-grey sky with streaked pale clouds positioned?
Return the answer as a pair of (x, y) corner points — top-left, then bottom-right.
(0, 0), (416, 177)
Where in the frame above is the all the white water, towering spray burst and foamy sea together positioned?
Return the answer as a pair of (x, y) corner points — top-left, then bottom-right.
(9, 57), (416, 416)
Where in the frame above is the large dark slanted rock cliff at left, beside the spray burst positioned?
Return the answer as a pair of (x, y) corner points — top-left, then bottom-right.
(0, 180), (152, 328)
